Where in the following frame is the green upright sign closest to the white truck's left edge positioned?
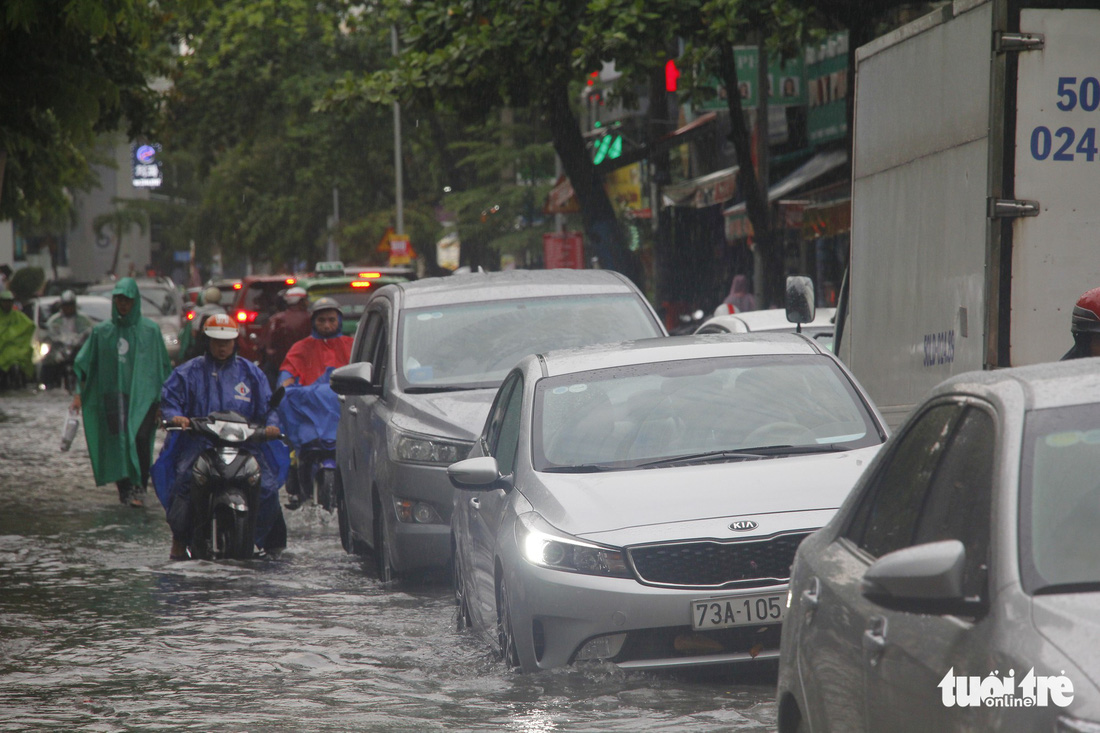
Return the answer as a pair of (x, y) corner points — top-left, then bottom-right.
(805, 31), (848, 145)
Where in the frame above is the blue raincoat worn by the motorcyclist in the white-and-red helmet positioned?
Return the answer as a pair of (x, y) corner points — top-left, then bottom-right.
(153, 354), (290, 548)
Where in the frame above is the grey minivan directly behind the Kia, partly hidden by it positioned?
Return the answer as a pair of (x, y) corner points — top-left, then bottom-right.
(332, 270), (666, 579)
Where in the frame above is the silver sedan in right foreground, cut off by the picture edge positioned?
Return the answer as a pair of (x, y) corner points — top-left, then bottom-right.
(778, 359), (1100, 733)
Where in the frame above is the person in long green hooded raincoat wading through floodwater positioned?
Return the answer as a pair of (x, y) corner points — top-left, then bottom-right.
(73, 277), (172, 507)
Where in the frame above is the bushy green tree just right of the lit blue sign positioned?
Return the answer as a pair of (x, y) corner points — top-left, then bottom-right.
(164, 0), (420, 268)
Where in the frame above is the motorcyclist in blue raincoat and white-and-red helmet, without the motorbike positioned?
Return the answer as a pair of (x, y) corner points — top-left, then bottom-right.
(153, 314), (290, 559)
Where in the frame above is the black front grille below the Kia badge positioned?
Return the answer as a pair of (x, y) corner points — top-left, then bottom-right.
(627, 533), (810, 588)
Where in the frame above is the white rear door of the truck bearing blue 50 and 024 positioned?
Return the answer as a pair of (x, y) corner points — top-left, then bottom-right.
(1010, 8), (1100, 365)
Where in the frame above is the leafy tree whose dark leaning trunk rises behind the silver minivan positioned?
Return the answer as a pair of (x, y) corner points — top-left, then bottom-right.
(333, 0), (635, 275)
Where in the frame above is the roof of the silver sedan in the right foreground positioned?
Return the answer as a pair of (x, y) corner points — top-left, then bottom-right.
(928, 359), (1100, 409)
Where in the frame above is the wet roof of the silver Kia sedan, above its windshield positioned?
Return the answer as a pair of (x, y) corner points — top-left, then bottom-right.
(525, 333), (832, 376)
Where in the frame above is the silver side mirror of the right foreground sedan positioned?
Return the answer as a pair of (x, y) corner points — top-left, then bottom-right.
(861, 539), (966, 613)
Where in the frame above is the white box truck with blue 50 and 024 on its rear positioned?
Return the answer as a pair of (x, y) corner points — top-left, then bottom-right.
(837, 0), (1100, 427)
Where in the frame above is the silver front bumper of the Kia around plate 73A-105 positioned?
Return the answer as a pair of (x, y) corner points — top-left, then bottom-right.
(508, 560), (788, 669)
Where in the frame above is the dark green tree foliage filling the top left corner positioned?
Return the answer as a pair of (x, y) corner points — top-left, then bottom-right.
(0, 0), (169, 226)
